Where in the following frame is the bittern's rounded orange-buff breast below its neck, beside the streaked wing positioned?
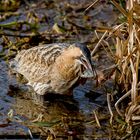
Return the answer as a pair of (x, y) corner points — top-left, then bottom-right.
(48, 58), (80, 93)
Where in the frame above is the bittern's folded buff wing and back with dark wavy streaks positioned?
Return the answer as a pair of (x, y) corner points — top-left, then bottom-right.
(10, 43), (69, 81)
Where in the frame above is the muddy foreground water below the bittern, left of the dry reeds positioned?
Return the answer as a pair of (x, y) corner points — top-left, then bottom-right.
(0, 55), (113, 139)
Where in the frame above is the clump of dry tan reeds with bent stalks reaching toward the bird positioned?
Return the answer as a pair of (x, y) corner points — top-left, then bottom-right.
(89, 0), (140, 131)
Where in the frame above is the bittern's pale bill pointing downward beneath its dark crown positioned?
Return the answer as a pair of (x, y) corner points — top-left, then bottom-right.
(80, 57), (94, 78)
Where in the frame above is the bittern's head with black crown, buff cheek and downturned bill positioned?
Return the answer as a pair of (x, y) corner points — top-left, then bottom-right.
(68, 43), (94, 78)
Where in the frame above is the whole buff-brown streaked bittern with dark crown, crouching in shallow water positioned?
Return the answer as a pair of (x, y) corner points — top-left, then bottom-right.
(10, 43), (93, 95)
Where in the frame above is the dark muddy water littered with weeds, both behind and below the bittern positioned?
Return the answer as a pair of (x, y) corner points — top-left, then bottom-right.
(0, 0), (119, 140)
